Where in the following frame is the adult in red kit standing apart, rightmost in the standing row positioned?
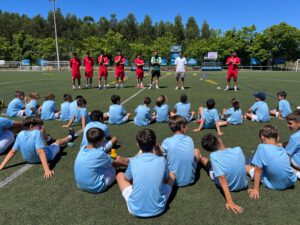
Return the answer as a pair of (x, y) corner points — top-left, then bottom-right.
(225, 52), (241, 91)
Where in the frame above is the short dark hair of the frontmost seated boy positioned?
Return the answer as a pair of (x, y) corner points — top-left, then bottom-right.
(136, 128), (156, 152)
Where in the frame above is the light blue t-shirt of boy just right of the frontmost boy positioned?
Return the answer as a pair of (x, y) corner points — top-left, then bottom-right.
(162, 134), (196, 187)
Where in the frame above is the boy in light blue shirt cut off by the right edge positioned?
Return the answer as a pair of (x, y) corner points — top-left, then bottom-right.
(285, 109), (300, 170)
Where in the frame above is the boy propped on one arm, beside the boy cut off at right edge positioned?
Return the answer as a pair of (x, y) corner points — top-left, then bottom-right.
(246, 125), (299, 199)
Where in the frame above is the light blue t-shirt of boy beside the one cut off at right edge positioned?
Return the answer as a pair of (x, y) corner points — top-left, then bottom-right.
(252, 144), (297, 190)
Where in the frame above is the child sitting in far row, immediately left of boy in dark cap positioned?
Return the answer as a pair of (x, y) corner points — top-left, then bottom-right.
(219, 98), (243, 127)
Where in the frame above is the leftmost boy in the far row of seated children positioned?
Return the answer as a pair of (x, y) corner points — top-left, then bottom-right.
(6, 91), (25, 117)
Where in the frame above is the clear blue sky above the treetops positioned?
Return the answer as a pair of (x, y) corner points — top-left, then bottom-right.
(0, 0), (300, 31)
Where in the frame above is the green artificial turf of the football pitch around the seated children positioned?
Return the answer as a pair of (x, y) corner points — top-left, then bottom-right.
(0, 71), (300, 225)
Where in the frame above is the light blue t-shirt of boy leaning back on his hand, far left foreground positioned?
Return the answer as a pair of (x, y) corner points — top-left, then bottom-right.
(13, 130), (53, 163)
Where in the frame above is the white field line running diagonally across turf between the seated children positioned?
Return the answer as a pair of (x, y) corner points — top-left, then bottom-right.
(0, 76), (167, 188)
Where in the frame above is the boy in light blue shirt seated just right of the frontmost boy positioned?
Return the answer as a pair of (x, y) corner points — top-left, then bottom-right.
(162, 115), (200, 187)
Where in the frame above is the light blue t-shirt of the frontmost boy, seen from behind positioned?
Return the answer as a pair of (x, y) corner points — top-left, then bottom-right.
(125, 153), (169, 217)
